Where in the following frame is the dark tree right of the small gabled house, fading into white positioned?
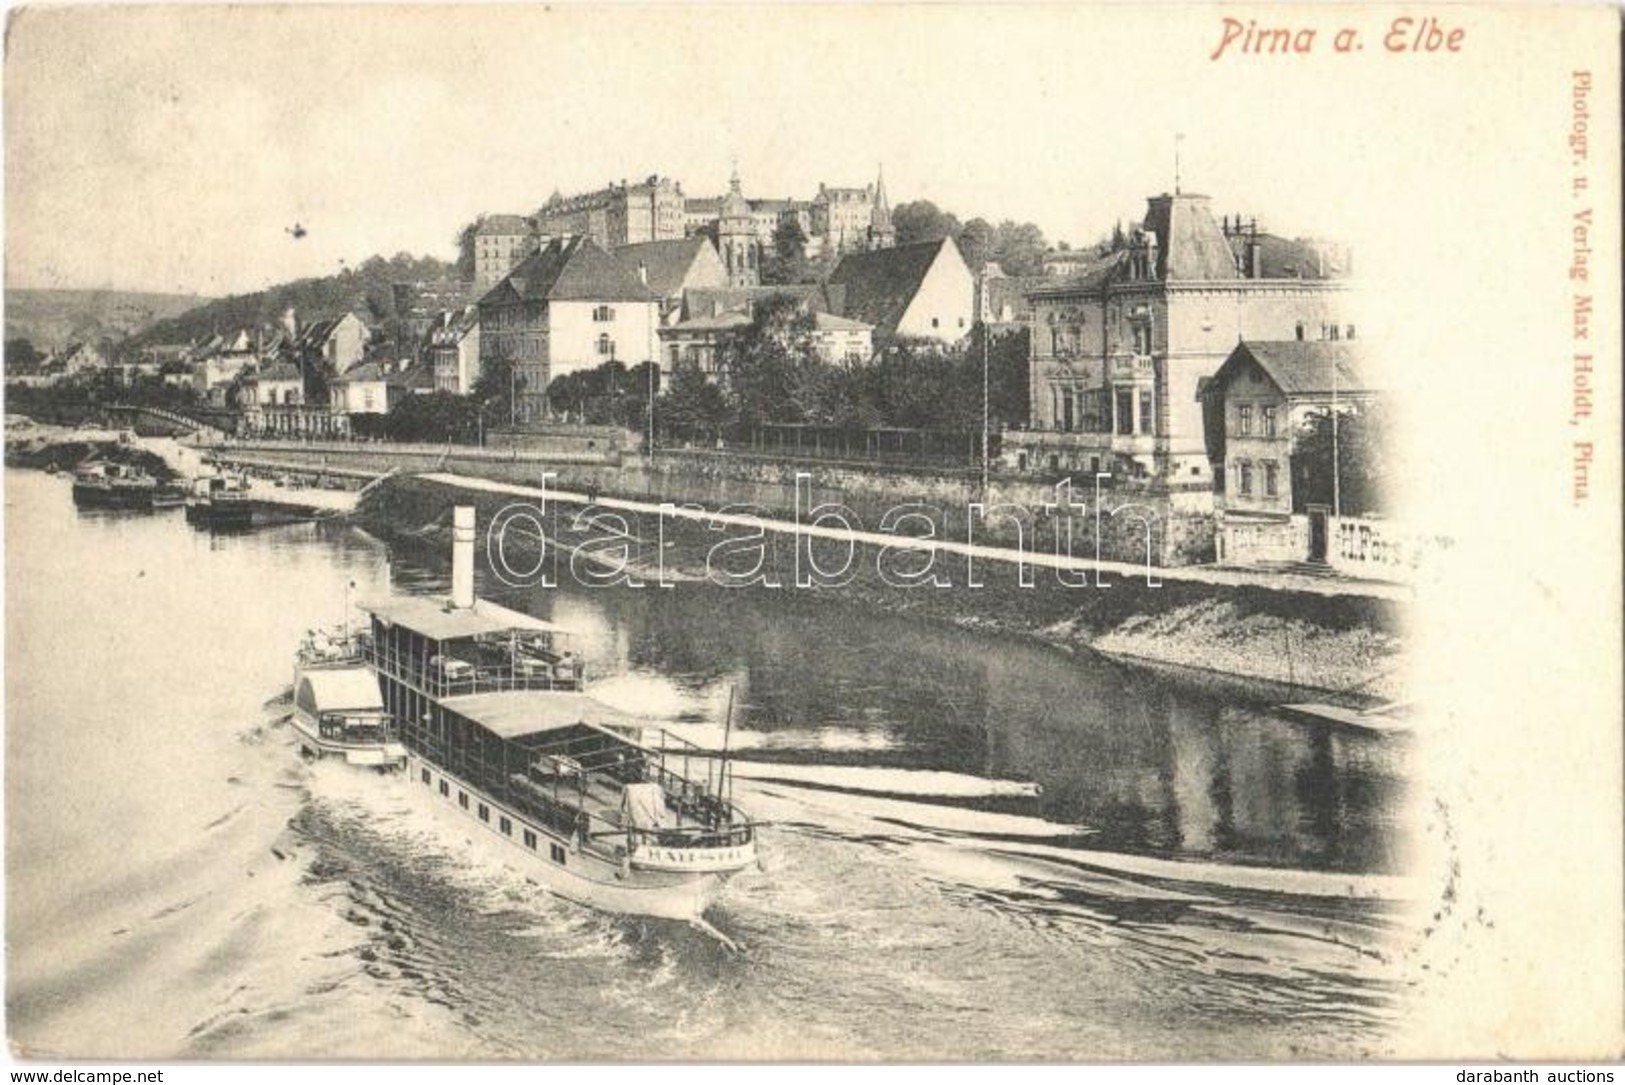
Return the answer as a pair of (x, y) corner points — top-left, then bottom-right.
(1292, 403), (1398, 517)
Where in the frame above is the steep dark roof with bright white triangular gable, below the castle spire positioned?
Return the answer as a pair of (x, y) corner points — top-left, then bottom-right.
(826, 237), (977, 343)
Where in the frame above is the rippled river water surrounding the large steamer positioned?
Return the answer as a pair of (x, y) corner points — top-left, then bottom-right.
(5, 471), (1412, 1061)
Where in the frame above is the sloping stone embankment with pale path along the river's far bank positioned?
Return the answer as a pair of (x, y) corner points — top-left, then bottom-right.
(359, 474), (1409, 707)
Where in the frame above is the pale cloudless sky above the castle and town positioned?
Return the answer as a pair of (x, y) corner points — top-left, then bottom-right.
(5, 5), (1560, 296)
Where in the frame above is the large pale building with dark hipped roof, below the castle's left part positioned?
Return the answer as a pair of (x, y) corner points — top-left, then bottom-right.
(479, 237), (660, 421)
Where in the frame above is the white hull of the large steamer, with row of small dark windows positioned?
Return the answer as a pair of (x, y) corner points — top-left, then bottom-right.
(406, 754), (736, 923)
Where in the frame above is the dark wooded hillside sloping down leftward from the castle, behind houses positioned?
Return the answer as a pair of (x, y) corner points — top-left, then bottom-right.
(119, 253), (455, 352)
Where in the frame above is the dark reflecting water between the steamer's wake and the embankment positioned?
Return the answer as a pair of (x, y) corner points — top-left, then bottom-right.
(412, 554), (1406, 872)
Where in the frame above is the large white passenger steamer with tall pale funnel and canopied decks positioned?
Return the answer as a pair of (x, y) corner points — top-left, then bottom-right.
(331, 507), (757, 923)
